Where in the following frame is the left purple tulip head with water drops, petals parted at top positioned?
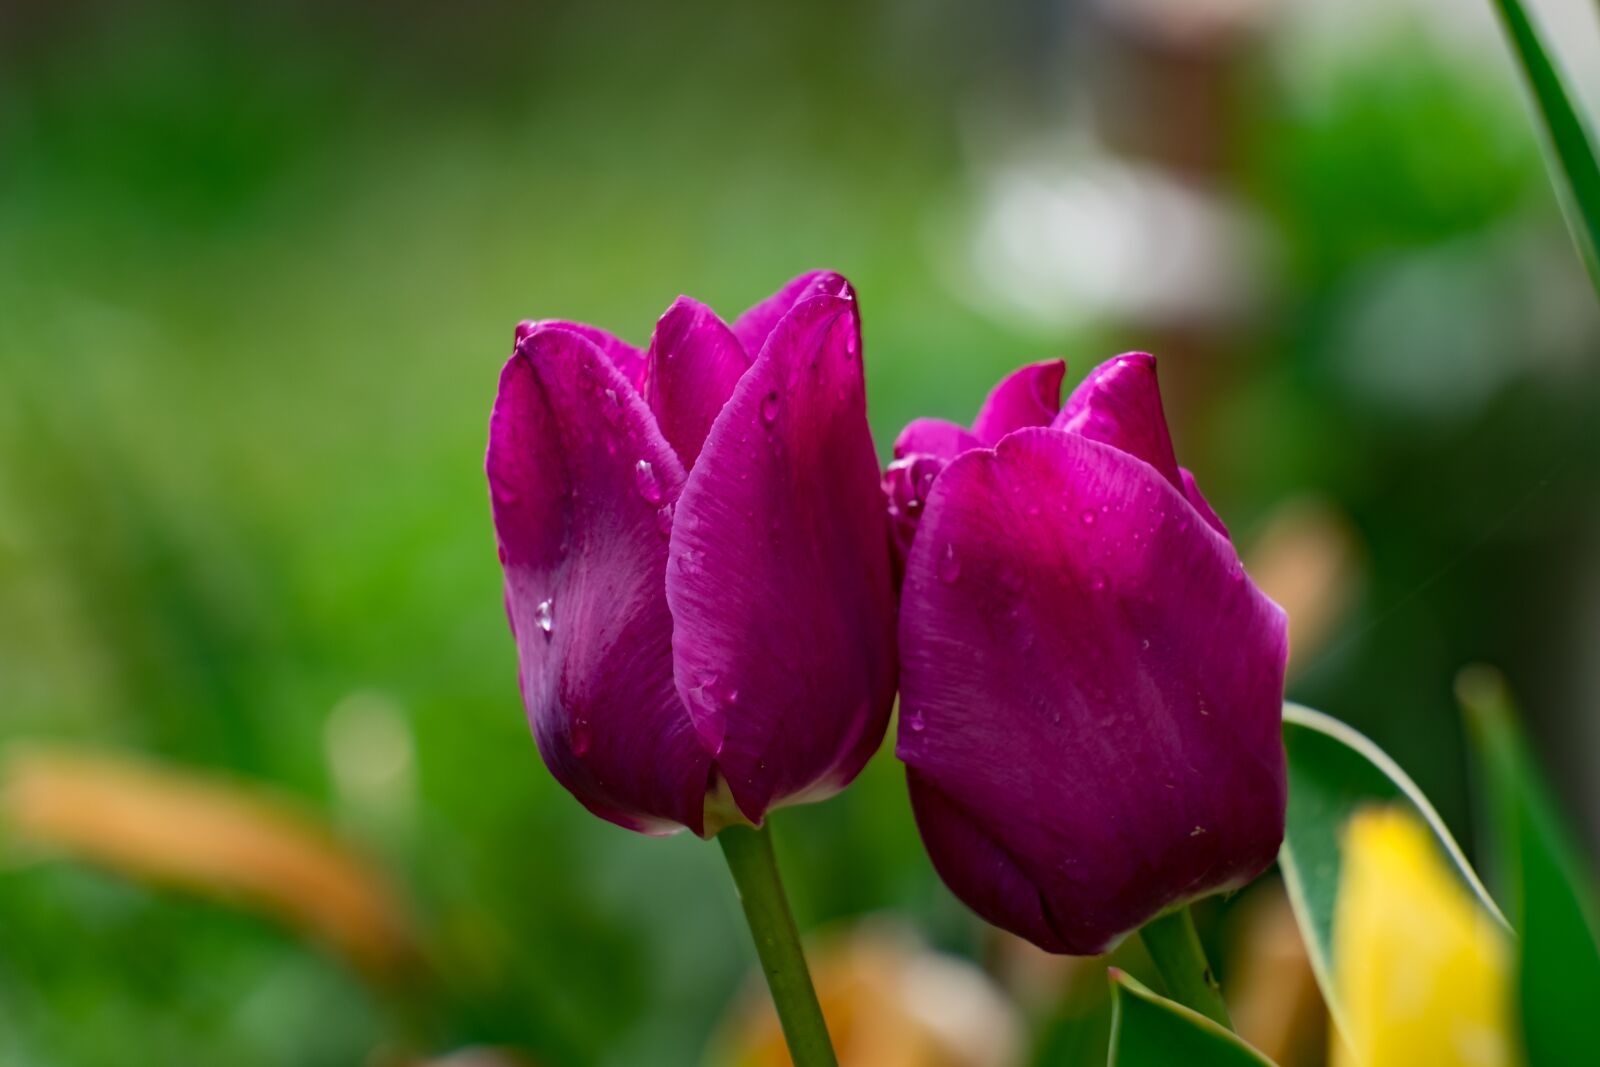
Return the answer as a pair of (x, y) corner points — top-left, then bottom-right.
(488, 272), (896, 835)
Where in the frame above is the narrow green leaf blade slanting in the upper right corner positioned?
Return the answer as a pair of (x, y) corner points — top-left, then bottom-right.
(1494, 0), (1600, 293)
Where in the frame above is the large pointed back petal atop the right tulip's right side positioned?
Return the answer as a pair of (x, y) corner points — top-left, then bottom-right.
(1054, 352), (1184, 489)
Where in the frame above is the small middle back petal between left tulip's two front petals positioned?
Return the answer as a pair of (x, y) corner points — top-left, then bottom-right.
(645, 296), (750, 469)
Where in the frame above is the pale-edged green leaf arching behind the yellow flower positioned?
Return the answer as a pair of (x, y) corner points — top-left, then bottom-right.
(1278, 704), (1506, 1030)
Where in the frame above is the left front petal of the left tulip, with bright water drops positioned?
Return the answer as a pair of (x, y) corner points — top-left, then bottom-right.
(488, 326), (710, 832)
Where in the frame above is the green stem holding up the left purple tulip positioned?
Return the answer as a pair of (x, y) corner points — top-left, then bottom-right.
(717, 825), (838, 1067)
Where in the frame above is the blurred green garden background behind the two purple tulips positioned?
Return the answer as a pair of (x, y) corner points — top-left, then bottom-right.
(0, 0), (1600, 1067)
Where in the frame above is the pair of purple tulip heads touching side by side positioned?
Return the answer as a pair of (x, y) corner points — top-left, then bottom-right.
(488, 274), (1286, 1036)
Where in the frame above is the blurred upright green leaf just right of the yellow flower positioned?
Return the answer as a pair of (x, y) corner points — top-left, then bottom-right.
(1456, 667), (1600, 1064)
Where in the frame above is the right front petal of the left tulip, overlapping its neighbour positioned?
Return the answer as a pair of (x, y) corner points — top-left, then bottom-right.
(667, 290), (896, 822)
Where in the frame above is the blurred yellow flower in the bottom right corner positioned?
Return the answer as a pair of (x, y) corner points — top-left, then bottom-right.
(1331, 808), (1518, 1067)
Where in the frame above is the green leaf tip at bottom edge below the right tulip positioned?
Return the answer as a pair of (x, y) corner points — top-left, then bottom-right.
(1106, 968), (1272, 1067)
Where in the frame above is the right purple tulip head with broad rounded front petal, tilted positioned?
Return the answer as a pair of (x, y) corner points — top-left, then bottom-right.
(885, 354), (1288, 955)
